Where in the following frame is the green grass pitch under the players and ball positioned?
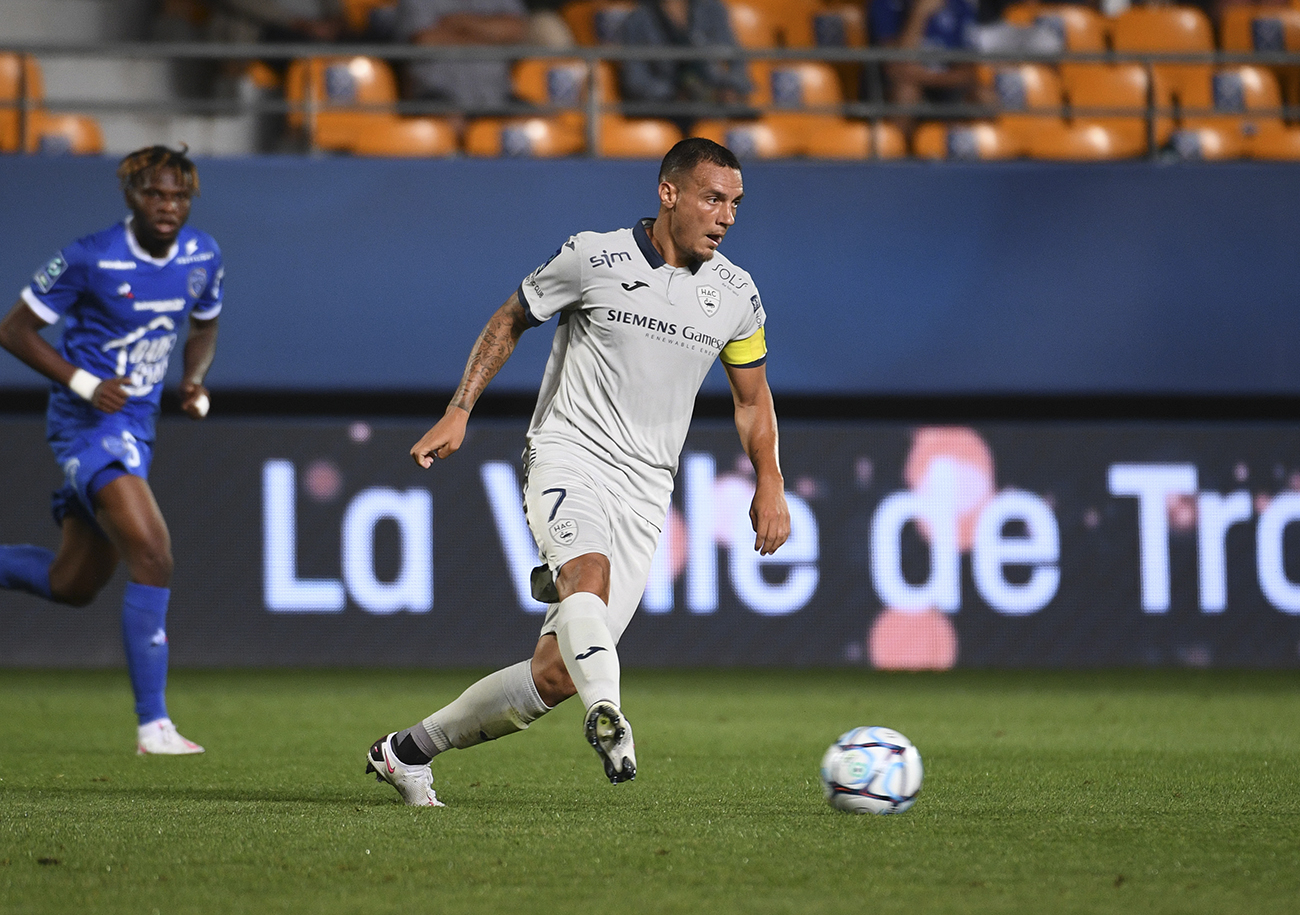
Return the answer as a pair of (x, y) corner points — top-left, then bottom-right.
(0, 671), (1300, 915)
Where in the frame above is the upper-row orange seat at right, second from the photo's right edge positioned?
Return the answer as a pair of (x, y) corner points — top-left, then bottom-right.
(1110, 6), (1214, 119)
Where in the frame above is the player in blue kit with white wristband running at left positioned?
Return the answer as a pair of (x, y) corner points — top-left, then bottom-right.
(0, 146), (222, 755)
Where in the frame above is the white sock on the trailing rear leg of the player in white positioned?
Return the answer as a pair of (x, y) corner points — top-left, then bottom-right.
(412, 660), (551, 756)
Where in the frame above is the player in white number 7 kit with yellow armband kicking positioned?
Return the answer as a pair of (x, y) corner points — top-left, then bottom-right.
(365, 138), (790, 806)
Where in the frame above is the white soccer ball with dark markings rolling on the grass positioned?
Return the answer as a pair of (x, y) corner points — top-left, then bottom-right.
(822, 728), (922, 814)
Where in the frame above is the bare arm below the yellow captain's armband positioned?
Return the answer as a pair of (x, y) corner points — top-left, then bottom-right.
(725, 365), (790, 556)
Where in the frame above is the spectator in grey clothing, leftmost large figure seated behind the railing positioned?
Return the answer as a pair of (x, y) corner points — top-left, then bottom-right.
(397, 0), (529, 114)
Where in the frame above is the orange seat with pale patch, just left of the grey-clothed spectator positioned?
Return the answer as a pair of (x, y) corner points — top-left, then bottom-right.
(285, 56), (454, 156)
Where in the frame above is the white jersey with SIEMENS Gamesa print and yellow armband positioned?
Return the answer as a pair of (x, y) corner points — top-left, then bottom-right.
(519, 220), (767, 529)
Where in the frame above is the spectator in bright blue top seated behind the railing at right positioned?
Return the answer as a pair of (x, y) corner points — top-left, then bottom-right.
(867, 0), (996, 130)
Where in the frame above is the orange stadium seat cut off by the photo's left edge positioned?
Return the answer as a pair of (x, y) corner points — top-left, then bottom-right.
(0, 53), (104, 155)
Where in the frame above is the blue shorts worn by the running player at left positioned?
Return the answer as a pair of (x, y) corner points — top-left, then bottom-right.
(49, 413), (153, 533)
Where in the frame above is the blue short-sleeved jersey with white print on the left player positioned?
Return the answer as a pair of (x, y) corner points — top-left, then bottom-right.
(22, 217), (224, 442)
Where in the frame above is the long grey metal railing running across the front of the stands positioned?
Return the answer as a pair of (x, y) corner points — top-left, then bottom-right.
(0, 42), (1300, 156)
